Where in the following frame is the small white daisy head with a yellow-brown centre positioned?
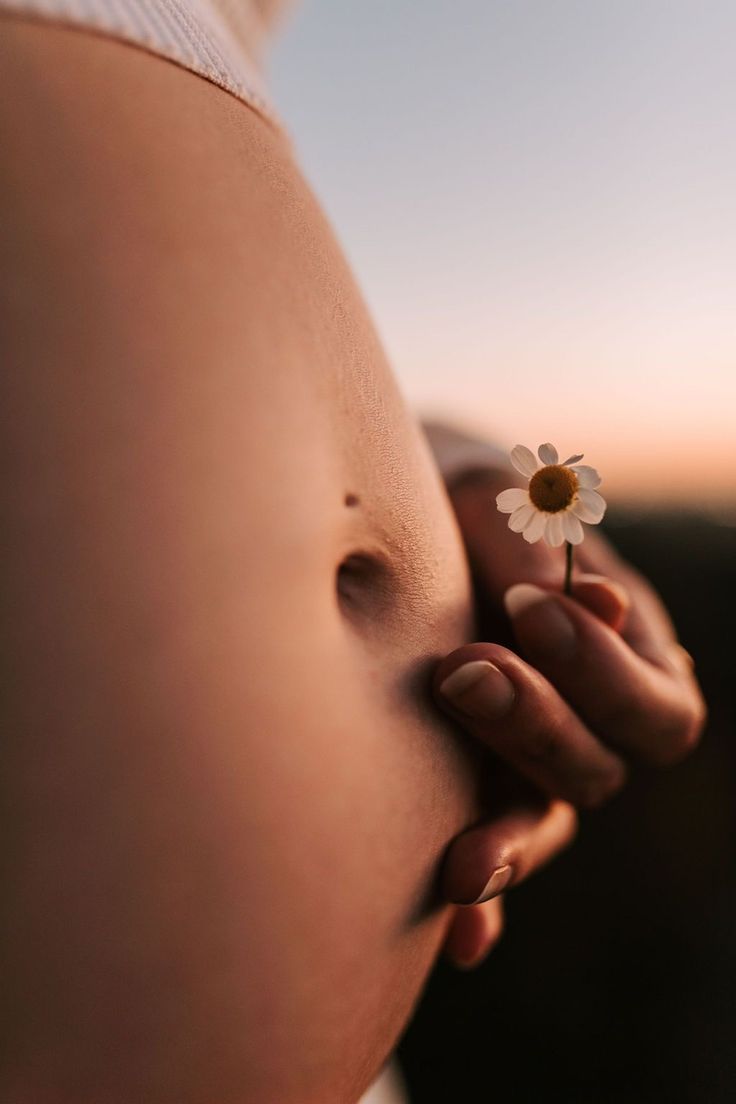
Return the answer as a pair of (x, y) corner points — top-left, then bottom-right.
(495, 444), (606, 548)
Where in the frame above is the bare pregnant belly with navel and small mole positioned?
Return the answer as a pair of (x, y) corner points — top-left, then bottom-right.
(0, 20), (474, 1104)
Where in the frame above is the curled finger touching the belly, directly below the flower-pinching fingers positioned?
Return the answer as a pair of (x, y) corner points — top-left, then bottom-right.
(434, 644), (626, 808)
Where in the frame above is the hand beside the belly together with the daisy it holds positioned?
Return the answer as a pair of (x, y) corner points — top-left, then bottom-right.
(435, 434), (705, 971)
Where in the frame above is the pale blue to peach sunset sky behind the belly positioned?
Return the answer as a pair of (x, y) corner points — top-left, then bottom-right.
(269, 0), (736, 507)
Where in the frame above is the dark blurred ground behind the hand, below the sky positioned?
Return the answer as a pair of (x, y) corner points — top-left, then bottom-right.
(399, 508), (736, 1104)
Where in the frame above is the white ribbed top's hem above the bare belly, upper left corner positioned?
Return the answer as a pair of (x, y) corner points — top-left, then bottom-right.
(0, 0), (284, 121)
